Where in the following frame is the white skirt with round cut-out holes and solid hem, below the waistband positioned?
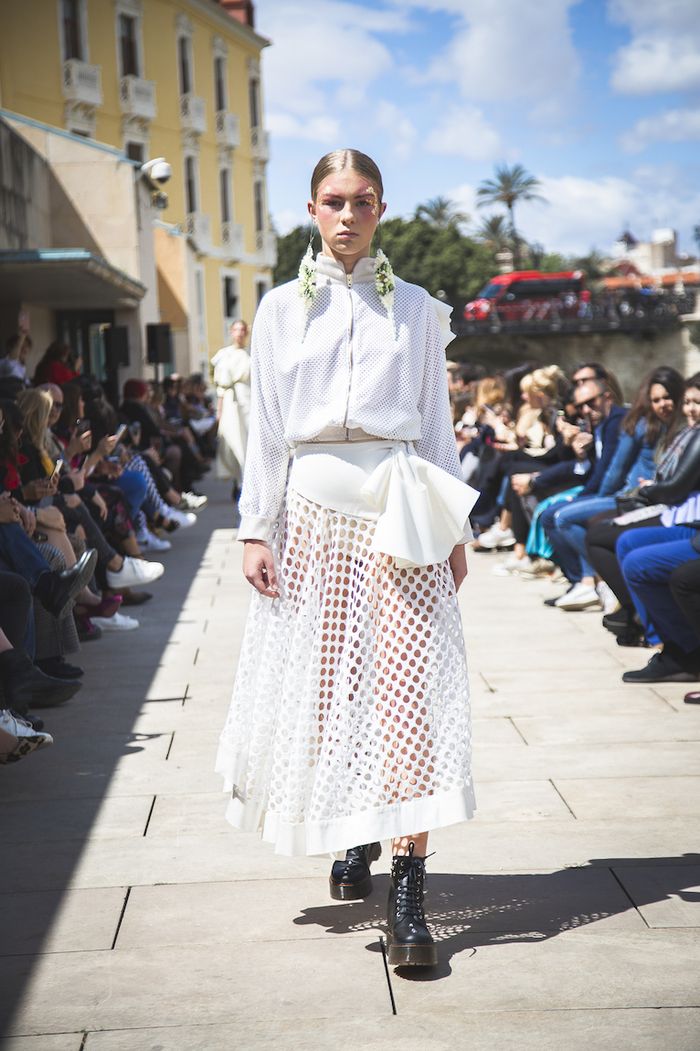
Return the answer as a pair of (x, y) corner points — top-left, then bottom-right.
(217, 451), (474, 854)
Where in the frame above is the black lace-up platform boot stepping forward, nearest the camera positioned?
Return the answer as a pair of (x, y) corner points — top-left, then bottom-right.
(387, 843), (437, 967)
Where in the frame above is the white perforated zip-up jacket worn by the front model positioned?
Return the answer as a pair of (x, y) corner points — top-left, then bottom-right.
(239, 254), (460, 541)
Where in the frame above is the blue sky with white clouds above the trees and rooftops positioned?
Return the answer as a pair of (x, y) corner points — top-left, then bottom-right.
(256, 0), (700, 259)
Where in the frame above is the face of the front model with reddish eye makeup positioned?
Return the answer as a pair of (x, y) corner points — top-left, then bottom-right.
(308, 168), (387, 270)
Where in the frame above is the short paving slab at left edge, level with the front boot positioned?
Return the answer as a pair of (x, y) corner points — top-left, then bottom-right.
(0, 887), (126, 956)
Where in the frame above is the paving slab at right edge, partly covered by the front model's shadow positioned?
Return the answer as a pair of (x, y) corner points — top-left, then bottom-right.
(615, 865), (700, 927)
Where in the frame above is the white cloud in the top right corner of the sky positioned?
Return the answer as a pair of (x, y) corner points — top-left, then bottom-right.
(609, 0), (700, 95)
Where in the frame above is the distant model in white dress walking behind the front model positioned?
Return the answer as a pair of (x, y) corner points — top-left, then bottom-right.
(211, 321), (250, 500)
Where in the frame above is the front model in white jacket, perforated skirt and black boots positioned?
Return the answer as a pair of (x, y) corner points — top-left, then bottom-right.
(217, 149), (477, 966)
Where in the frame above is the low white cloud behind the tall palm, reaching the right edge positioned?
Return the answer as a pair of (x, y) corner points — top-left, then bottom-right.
(447, 168), (700, 254)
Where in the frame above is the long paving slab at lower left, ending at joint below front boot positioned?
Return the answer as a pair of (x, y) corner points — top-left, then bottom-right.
(0, 935), (391, 1034)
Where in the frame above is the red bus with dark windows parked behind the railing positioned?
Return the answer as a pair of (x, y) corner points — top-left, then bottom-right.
(465, 270), (585, 322)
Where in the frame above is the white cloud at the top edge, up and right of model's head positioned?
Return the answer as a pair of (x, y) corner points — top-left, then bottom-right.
(420, 0), (580, 114)
